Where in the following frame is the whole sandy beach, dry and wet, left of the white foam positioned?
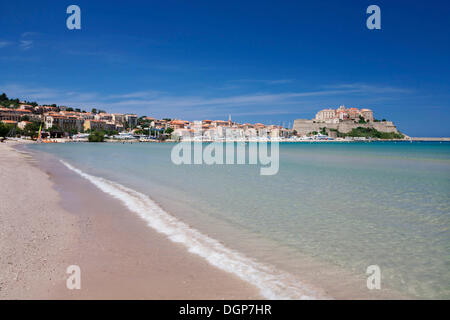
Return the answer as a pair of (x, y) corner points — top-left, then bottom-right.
(0, 142), (261, 299)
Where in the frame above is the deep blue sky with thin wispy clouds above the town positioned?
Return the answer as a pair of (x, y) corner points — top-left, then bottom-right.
(0, 0), (450, 136)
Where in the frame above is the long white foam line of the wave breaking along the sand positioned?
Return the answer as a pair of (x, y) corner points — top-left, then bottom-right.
(60, 160), (325, 299)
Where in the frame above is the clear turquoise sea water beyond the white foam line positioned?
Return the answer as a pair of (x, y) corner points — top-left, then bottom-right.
(30, 142), (450, 299)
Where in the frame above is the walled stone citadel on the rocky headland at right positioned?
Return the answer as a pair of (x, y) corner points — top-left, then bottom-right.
(293, 106), (400, 137)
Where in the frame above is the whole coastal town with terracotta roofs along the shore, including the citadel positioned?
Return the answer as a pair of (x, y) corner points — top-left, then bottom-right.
(0, 93), (407, 142)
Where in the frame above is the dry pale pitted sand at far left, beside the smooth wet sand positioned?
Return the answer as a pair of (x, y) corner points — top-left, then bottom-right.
(0, 141), (79, 299)
